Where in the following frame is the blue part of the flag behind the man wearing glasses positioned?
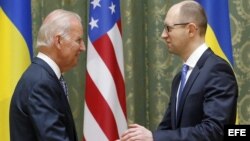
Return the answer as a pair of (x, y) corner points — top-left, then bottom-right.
(197, 0), (233, 64)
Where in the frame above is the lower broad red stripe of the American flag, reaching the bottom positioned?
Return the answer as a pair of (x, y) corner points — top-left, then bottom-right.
(85, 72), (119, 141)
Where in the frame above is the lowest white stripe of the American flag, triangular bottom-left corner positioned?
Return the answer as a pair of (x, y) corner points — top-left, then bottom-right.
(83, 103), (108, 141)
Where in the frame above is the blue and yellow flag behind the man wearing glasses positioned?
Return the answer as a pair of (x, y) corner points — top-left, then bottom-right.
(196, 0), (239, 124)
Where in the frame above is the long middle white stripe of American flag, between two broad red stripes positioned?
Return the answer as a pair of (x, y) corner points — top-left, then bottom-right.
(87, 37), (127, 135)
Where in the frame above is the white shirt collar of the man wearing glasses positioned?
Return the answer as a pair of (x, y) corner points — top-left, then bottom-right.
(185, 43), (208, 68)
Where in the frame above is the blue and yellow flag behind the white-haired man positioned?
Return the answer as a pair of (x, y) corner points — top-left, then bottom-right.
(0, 0), (33, 141)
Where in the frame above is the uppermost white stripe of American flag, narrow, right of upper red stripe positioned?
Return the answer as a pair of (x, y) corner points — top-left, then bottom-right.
(108, 24), (124, 79)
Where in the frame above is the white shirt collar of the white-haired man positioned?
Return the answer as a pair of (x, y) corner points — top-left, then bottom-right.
(37, 52), (61, 79)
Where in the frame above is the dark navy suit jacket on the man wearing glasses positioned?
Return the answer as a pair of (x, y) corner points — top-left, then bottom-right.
(153, 49), (238, 141)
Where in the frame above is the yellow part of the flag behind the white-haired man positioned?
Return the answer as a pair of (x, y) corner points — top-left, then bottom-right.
(0, 0), (31, 141)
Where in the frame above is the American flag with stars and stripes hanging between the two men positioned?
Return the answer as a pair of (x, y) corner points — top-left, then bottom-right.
(83, 0), (127, 141)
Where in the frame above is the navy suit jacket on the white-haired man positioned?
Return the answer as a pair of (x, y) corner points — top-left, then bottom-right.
(10, 58), (77, 141)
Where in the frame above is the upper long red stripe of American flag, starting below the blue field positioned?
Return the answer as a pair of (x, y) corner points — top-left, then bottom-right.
(93, 34), (127, 117)
